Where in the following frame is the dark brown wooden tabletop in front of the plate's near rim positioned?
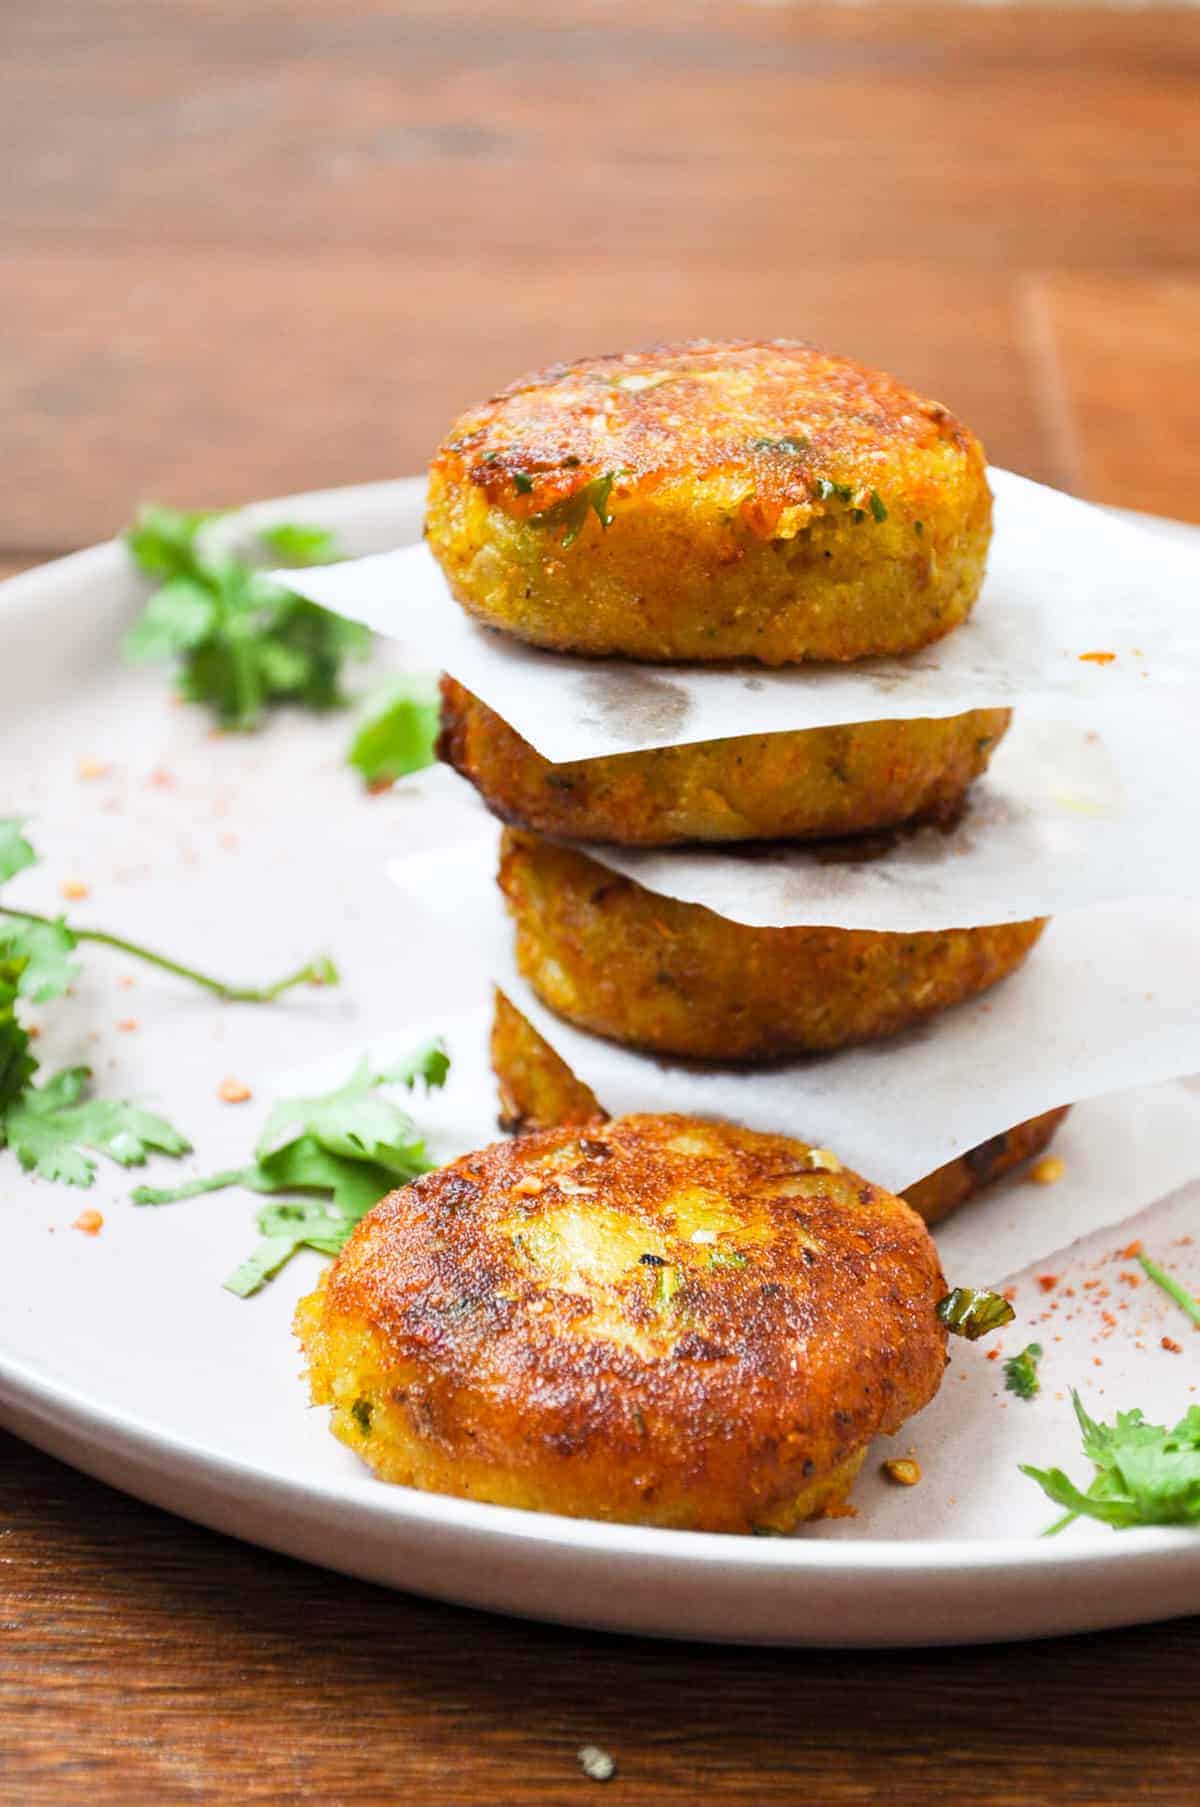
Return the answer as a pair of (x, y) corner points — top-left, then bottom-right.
(0, 1438), (1200, 1807)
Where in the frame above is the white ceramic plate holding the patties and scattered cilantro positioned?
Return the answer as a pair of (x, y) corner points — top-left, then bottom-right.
(0, 482), (1200, 1644)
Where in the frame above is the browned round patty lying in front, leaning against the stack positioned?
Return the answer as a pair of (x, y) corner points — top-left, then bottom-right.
(296, 1117), (945, 1531)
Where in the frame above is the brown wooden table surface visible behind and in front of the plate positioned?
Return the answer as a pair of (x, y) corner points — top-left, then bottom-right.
(0, 0), (1200, 1807)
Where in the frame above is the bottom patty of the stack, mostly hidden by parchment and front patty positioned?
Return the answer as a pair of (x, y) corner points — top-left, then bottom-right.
(492, 990), (1070, 1223)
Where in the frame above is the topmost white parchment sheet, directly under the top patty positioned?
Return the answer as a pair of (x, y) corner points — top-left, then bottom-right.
(276, 470), (1200, 761)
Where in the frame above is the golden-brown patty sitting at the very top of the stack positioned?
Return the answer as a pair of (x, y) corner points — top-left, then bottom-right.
(427, 340), (992, 665)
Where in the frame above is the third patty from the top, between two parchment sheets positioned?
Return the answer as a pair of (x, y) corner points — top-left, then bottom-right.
(499, 828), (1045, 1061)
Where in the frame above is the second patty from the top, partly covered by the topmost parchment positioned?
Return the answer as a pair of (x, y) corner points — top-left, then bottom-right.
(437, 678), (1010, 847)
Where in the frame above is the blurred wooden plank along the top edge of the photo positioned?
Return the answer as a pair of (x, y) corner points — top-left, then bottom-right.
(0, 0), (1200, 269)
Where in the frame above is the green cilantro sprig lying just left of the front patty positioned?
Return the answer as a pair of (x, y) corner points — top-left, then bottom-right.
(132, 1041), (450, 1299)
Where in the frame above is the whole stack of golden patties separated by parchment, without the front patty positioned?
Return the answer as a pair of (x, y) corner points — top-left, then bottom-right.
(427, 342), (1061, 1216)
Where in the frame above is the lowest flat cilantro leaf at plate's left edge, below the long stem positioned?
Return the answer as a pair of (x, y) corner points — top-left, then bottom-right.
(2, 1066), (192, 1185)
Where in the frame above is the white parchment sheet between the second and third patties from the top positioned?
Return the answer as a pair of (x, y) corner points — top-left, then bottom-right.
(563, 699), (1200, 932)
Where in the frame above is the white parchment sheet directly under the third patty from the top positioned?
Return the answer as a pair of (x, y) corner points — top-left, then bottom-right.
(387, 835), (1200, 1191)
